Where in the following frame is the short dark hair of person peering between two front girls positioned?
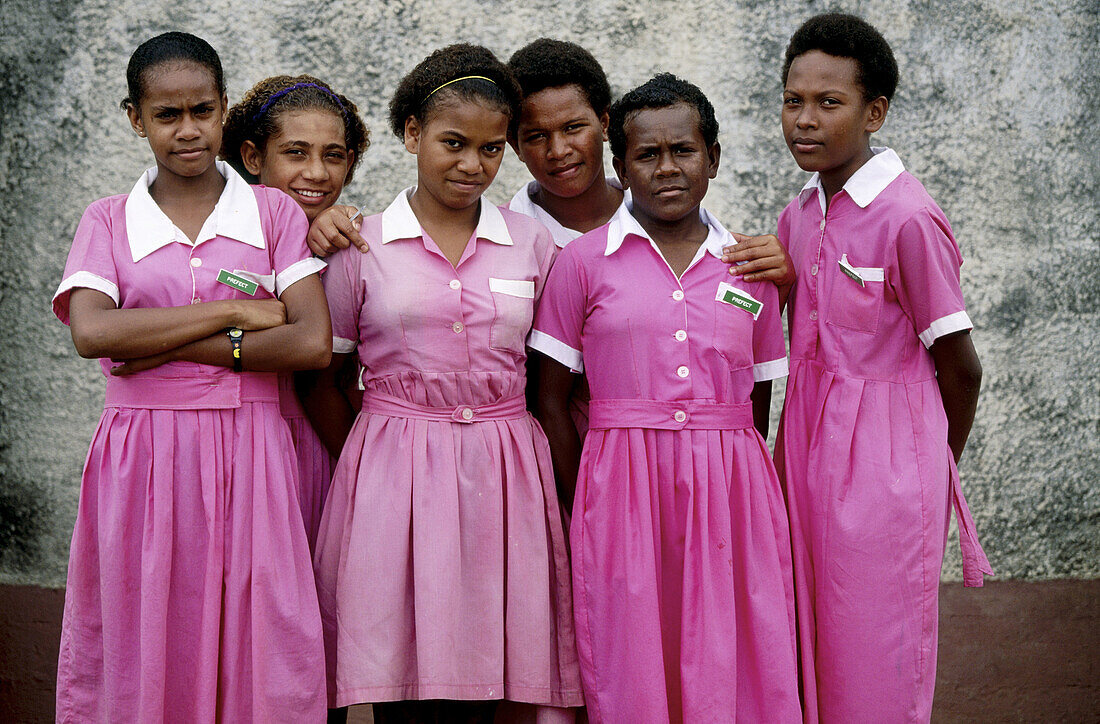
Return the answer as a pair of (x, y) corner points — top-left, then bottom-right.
(508, 37), (612, 116)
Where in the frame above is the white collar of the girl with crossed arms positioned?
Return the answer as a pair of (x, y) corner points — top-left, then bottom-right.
(125, 161), (264, 263)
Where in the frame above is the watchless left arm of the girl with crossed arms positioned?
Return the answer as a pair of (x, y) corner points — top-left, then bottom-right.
(69, 287), (286, 360)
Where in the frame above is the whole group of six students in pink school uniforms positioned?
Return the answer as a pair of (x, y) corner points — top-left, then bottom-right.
(54, 14), (990, 723)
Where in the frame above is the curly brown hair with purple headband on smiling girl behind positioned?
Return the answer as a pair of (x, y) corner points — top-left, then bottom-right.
(221, 75), (371, 184)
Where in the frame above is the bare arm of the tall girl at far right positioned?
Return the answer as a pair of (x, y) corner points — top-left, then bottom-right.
(930, 331), (981, 463)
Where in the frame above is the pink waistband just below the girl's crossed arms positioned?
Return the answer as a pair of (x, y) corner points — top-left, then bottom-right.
(103, 372), (278, 409)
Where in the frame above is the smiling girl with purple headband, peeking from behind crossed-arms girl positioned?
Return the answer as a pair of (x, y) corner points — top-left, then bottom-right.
(221, 75), (370, 548)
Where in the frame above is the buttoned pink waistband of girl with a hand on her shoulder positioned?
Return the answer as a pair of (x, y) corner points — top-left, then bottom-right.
(589, 399), (752, 430)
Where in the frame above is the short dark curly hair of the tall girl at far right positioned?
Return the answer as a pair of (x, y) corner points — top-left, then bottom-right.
(783, 12), (898, 101)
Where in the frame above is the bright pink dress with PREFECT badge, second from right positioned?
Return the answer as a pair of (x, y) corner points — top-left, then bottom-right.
(529, 207), (802, 724)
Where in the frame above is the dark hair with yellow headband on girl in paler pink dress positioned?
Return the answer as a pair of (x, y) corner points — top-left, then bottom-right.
(389, 43), (520, 140)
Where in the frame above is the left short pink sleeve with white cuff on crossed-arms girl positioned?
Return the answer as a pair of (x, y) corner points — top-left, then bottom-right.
(53, 199), (119, 325)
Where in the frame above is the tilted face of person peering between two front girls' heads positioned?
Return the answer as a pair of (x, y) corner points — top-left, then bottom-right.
(515, 85), (607, 198)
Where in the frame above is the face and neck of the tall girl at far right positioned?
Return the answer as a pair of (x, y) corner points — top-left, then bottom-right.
(782, 51), (889, 196)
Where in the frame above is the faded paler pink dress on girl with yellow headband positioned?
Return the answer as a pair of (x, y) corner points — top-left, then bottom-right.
(315, 189), (583, 716)
